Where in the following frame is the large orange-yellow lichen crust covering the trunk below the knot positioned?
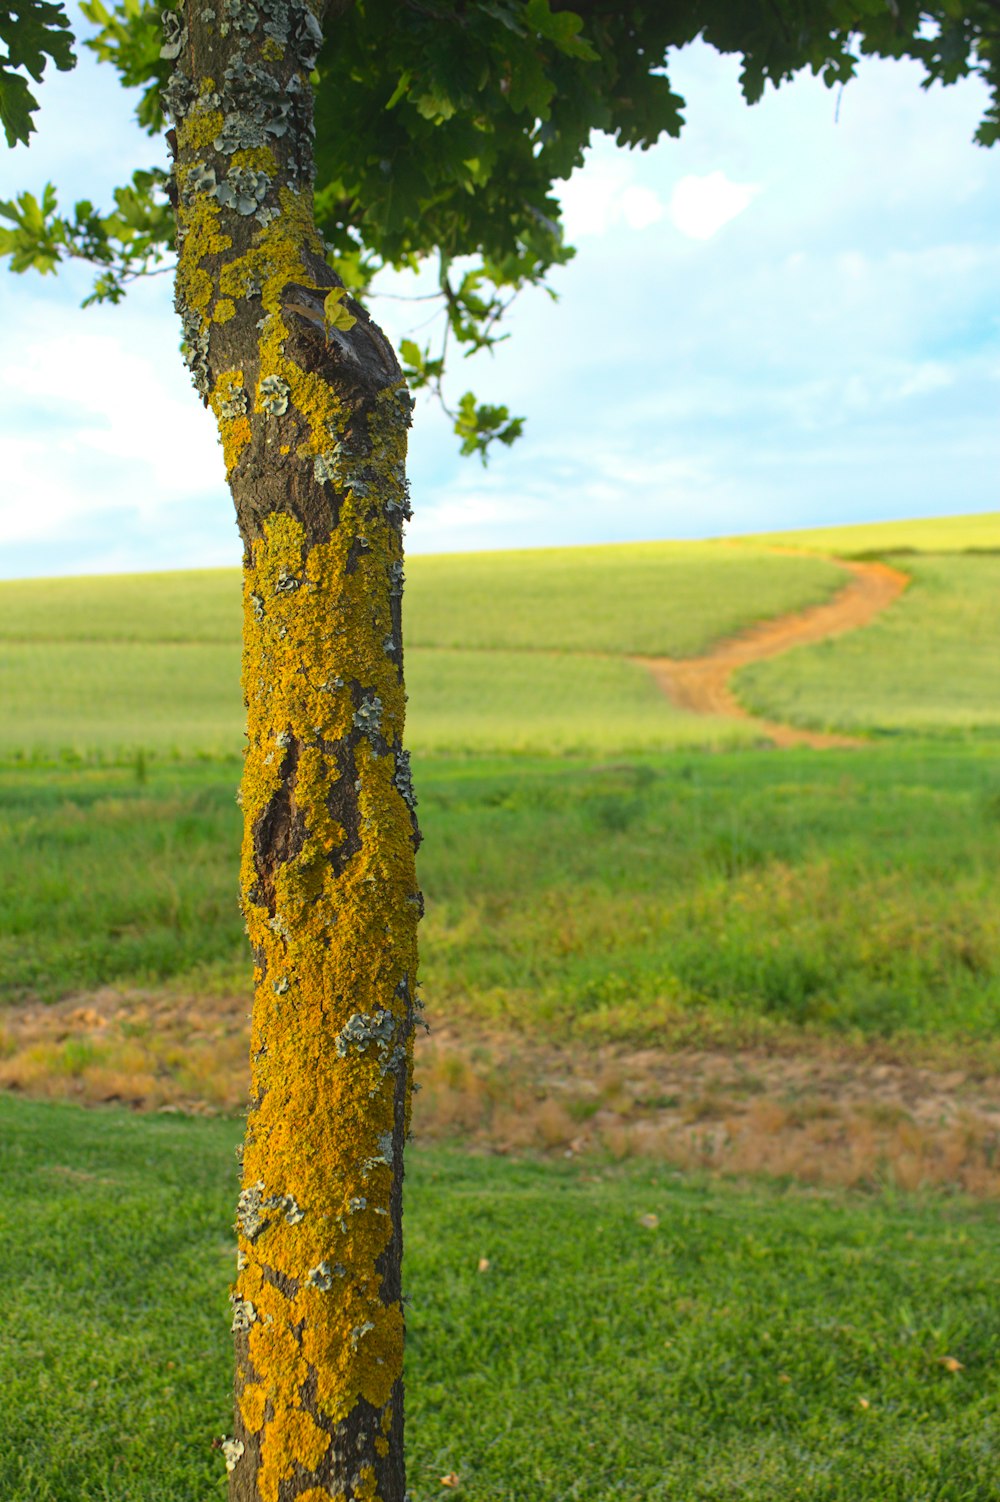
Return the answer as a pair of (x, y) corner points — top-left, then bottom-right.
(237, 453), (416, 1502)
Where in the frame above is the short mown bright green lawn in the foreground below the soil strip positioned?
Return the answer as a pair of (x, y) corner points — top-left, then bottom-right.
(0, 1098), (1000, 1502)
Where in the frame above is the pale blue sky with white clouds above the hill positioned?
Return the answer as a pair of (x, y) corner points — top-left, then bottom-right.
(0, 21), (1000, 578)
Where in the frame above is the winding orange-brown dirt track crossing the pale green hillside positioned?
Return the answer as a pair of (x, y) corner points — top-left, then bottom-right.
(632, 550), (910, 749)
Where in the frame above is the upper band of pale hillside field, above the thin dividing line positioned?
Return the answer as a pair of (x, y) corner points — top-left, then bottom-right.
(0, 542), (842, 656)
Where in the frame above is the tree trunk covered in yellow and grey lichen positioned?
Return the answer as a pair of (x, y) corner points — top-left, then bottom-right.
(164, 0), (420, 1502)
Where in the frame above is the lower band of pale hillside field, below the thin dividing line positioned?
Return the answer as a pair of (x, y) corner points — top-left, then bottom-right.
(0, 641), (757, 763)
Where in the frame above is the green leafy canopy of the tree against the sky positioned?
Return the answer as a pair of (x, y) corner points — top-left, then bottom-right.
(0, 0), (1000, 457)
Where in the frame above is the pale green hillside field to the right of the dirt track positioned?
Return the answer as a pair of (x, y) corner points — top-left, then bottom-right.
(734, 554), (1000, 736)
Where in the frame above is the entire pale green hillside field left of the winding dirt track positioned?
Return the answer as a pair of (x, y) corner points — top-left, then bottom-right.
(0, 544), (842, 760)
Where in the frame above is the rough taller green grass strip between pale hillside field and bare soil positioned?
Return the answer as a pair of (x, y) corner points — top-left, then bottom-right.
(7, 743), (1000, 1044)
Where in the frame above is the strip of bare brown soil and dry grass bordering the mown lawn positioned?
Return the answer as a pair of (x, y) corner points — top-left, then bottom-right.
(0, 990), (1000, 1199)
